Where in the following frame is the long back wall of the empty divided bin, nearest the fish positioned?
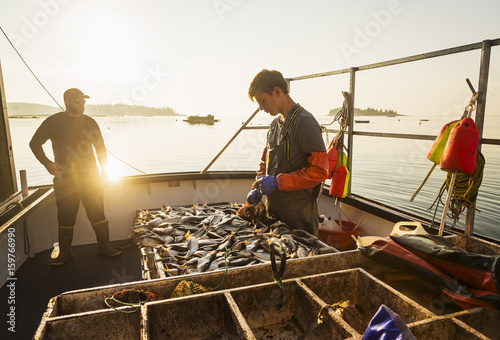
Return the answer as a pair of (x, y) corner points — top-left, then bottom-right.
(38, 251), (382, 317)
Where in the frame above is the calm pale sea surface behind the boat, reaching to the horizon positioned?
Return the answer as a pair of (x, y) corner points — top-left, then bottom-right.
(9, 112), (500, 239)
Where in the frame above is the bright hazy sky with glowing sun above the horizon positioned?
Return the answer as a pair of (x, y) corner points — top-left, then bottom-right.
(0, 0), (500, 116)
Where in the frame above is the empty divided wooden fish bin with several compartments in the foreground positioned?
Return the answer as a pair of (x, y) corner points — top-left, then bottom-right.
(34, 255), (500, 340)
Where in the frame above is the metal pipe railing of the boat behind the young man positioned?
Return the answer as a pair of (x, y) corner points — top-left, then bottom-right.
(201, 38), (500, 235)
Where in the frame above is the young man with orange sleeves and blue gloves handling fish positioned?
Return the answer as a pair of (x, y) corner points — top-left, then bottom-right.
(247, 69), (328, 236)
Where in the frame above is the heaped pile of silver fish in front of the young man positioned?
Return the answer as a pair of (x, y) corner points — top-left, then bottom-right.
(130, 203), (326, 274)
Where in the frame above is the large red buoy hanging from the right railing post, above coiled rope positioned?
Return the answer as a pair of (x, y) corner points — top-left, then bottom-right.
(440, 118), (479, 174)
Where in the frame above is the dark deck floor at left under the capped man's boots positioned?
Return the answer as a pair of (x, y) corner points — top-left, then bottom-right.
(0, 240), (142, 339)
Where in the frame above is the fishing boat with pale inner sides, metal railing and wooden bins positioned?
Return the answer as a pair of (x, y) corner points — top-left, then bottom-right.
(0, 39), (500, 339)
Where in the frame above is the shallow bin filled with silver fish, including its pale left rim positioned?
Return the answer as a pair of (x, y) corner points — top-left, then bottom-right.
(132, 203), (338, 280)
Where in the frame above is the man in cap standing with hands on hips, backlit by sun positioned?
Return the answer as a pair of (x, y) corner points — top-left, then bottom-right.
(30, 88), (121, 266)
